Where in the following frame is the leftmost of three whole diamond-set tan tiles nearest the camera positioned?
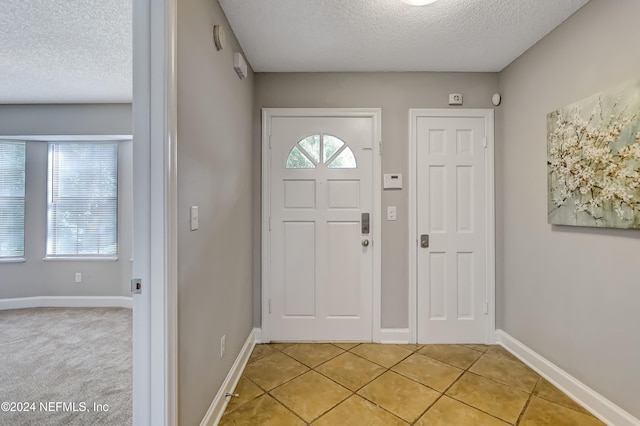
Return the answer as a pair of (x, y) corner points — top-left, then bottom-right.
(271, 371), (352, 422)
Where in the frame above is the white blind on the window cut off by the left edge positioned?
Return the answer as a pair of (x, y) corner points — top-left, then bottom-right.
(0, 141), (25, 258)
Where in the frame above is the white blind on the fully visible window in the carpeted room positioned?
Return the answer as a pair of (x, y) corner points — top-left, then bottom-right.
(47, 142), (118, 257)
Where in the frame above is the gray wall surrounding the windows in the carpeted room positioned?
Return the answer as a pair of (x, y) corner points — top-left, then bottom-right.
(0, 104), (133, 299)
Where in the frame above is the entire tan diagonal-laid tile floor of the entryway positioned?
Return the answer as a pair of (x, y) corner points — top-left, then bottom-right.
(220, 343), (604, 426)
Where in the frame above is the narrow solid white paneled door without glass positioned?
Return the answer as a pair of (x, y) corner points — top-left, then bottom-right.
(412, 110), (493, 343)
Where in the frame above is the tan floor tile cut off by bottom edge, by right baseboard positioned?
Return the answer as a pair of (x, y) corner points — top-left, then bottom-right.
(519, 395), (604, 426)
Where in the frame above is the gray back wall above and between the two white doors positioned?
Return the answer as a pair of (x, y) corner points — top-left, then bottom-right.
(254, 73), (498, 328)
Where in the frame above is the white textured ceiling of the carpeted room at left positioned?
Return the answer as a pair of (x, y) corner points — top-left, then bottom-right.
(0, 0), (132, 103)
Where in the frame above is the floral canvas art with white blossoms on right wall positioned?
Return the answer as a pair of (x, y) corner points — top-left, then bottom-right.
(547, 81), (640, 229)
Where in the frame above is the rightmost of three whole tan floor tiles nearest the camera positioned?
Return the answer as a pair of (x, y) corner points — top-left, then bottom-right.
(447, 372), (529, 424)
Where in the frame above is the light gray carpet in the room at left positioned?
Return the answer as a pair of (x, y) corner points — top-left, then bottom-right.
(0, 308), (132, 426)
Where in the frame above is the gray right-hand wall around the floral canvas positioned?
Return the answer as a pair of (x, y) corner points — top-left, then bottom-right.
(498, 0), (640, 417)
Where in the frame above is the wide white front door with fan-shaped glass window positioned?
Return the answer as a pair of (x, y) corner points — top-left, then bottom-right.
(263, 110), (377, 341)
